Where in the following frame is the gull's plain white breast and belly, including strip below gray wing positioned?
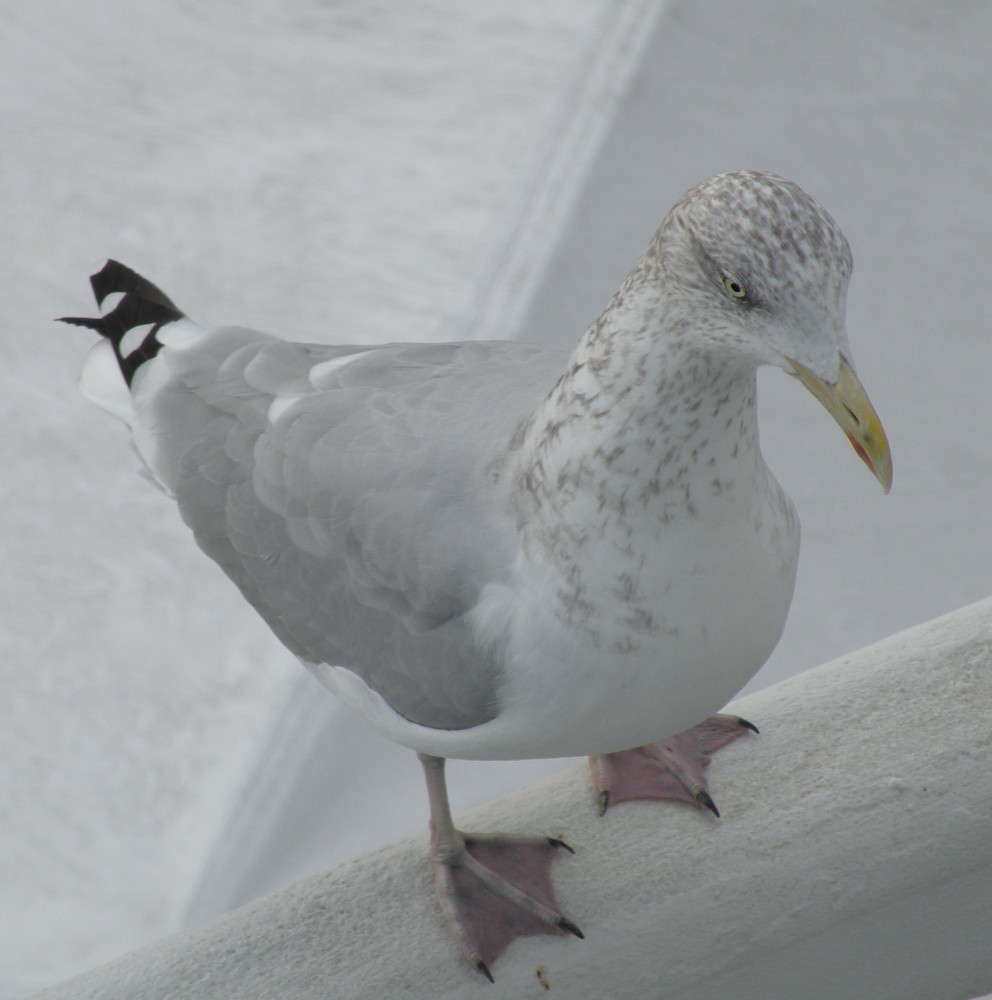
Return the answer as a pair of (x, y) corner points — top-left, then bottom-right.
(312, 464), (799, 760)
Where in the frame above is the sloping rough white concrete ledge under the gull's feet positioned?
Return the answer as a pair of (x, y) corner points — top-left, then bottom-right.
(38, 600), (992, 1000)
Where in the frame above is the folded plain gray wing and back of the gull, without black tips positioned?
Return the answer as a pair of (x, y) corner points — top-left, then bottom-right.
(138, 328), (565, 729)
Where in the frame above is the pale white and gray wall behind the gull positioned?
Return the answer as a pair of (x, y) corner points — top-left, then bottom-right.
(0, 0), (992, 997)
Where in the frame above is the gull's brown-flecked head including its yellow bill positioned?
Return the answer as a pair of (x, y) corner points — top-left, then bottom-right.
(652, 171), (892, 492)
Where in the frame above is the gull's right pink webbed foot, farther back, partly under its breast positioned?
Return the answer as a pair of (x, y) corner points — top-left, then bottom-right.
(589, 715), (758, 816)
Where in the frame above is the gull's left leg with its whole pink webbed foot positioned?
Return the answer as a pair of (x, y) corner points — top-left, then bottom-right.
(417, 754), (582, 980)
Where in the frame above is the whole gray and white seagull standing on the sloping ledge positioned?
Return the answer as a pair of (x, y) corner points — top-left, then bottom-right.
(65, 171), (892, 979)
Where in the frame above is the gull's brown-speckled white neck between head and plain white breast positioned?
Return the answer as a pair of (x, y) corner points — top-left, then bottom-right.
(516, 256), (765, 549)
